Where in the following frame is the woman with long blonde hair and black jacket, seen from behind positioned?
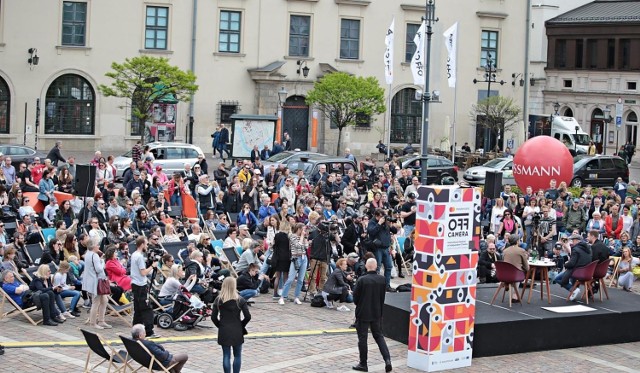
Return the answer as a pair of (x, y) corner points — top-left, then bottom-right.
(211, 277), (251, 373)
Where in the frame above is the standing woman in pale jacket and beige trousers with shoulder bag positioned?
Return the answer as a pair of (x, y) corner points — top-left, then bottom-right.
(82, 235), (111, 329)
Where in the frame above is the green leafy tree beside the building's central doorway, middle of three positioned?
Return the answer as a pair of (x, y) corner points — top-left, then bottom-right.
(307, 72), (386, 155)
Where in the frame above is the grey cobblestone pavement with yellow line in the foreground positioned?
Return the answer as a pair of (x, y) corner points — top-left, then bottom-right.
(0, 272), (640, 373)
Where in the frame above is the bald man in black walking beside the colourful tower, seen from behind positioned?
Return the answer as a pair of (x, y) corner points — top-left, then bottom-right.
(353, 258), (392, 372)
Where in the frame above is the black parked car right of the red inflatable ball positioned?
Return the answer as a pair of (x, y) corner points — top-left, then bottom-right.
(571, 155), (629, 187)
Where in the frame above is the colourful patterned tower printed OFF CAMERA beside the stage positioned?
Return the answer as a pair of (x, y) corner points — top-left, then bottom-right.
(407, 186), (482, 372)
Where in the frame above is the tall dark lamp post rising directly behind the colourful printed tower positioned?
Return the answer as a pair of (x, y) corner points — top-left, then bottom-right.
(420, 0), (438, 185)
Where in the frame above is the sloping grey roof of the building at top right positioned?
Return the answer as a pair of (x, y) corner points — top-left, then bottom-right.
(547, 0), (640, 25)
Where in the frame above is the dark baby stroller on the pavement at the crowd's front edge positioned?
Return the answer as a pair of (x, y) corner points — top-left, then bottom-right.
(156, 286), (212, 331)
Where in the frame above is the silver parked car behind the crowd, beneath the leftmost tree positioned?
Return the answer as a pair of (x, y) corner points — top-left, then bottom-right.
(113, 142), (205, 179)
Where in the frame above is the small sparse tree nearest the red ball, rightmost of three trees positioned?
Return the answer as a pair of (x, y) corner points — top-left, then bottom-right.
(470, 96), (522, 151)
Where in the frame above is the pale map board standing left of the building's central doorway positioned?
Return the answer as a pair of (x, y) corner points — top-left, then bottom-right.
(231, 119), (276, 158)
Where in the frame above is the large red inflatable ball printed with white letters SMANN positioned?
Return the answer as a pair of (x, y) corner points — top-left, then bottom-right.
(513, 136), (573, 193)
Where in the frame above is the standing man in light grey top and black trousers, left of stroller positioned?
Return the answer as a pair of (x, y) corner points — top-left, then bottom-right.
(131, 237), (158, 338)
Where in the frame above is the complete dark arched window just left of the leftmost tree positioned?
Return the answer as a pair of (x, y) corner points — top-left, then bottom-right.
(44, 74), (96, 135)
